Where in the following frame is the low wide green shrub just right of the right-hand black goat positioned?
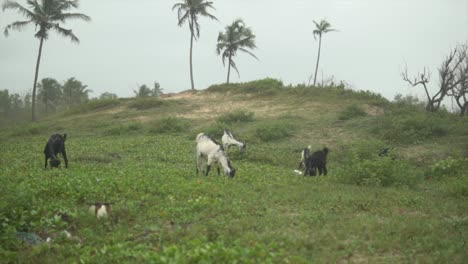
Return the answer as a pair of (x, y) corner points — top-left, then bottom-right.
(337, 156), (423, 187)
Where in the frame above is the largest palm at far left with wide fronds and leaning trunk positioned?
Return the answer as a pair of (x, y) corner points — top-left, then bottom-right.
(2, 0), (91, 121)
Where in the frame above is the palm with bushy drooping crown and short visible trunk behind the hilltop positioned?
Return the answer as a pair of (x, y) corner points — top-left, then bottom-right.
(216, 19), (258, 83)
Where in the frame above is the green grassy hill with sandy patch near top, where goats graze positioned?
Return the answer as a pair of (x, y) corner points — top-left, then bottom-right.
(0, 79), (468, 263)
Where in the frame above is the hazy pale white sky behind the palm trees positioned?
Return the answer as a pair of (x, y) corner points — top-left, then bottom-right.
(0, 0), (468, 99)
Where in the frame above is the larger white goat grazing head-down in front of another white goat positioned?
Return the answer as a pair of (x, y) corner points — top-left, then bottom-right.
(196, 133), (236, 178)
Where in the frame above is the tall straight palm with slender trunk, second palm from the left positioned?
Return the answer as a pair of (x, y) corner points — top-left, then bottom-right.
(172, 0), (218, 90)
